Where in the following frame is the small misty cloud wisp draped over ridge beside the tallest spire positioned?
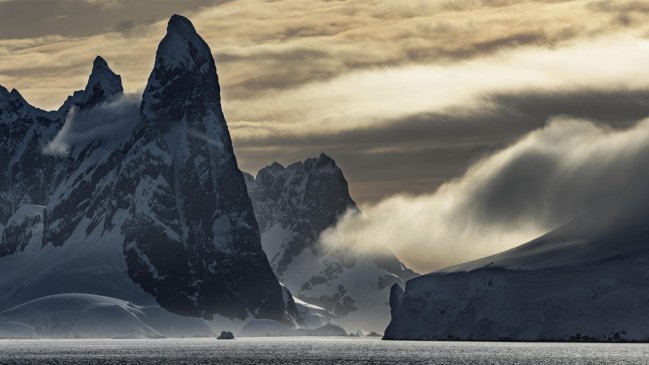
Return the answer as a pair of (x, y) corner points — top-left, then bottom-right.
(43, 94), (141, 155)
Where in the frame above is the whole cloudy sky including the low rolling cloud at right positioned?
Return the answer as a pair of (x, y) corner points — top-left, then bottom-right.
(0, 0), (649, 271)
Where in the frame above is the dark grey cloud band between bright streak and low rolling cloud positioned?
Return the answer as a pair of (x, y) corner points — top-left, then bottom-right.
(233, 90), (649, 201)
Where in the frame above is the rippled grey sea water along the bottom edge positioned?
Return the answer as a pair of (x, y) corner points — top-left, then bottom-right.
(0, 337), (649, 365)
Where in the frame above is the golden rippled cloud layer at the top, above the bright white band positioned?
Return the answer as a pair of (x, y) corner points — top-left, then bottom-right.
(0, 0), (649, 109)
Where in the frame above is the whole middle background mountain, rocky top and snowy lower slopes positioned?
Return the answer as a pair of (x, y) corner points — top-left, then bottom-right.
(246, 154), (415, 331)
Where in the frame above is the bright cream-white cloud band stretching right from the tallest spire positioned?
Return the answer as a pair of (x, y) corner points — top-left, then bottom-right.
(225, 35), (649, 136)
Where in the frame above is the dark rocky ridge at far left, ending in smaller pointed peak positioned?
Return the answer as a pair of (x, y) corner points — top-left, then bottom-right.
(0, 51), (123, 223)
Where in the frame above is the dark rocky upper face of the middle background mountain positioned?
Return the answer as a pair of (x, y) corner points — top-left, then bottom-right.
(248, 154), (356, 277)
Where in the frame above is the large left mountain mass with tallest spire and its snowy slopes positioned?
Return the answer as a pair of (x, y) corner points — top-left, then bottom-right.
(0, 15), (300, 325)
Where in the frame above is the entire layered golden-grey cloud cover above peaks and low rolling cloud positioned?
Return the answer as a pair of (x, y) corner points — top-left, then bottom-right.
(6, 0), (649, 208)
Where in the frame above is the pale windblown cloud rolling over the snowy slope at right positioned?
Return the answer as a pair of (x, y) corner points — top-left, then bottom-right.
(321, 117), (649, 272)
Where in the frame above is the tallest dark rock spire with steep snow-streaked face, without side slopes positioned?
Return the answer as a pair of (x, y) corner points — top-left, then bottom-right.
(116, 16), (294, 319)
